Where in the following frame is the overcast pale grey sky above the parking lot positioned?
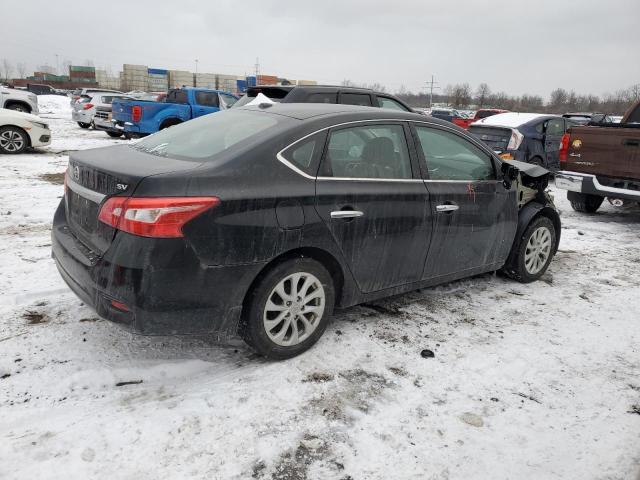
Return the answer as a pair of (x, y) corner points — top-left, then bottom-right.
(0, 0), (640, 97)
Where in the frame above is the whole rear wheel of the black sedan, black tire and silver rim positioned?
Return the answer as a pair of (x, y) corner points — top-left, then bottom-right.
(239, 258), (335, 360)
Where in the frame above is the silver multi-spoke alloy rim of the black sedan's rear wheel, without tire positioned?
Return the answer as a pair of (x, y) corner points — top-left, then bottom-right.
(263, 272), (326, 347)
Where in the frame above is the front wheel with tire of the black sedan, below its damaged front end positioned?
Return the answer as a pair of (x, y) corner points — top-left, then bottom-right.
(502, 217), (557, 283)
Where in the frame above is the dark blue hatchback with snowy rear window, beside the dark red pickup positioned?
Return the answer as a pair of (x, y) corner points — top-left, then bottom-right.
(469, 112), (576, 169)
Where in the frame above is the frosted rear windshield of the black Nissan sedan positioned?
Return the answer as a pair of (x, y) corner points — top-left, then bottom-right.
(133, 110), (282, 160)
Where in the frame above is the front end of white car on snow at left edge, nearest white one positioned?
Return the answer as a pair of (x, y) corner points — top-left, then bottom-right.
(0, 108), (51, 154)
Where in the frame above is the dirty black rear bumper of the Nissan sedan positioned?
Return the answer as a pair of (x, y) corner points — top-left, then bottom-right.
(51, 201), (262, 341)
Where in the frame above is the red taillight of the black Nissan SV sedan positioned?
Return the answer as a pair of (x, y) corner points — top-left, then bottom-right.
(98, 197), (220, 238)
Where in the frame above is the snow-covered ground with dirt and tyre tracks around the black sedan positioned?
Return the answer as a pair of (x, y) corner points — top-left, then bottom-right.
(0, 97), (640, 480)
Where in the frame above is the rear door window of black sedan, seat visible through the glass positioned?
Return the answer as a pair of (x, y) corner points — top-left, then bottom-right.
(321, 125), (412, 179)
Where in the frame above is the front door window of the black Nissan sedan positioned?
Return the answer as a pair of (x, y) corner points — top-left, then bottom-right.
(416, 126), (496, 181)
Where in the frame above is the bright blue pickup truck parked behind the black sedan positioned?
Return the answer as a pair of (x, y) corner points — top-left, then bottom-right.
(111, 87), (238, 138)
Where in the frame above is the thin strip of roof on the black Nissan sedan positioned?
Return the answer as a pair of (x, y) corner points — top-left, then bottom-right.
(240, 103), (440, 123)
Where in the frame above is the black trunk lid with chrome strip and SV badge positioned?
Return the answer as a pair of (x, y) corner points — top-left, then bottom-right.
(65, 145), (200, 255)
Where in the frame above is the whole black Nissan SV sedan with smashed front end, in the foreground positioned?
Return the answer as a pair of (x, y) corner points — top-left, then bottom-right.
(52, 104), (560, 359)
